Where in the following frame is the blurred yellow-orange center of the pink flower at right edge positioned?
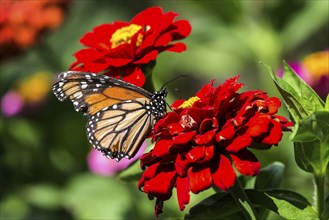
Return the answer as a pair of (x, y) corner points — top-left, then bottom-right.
(302, 51), (329, 79)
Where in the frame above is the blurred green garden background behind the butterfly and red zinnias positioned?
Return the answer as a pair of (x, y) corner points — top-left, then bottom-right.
(0, 0), (329, 220)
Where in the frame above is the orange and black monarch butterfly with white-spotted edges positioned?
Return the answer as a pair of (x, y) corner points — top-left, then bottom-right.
(53, 71), (167, 161)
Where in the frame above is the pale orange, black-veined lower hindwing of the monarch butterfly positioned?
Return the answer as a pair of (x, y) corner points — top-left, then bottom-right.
(87, 98), (154, 160)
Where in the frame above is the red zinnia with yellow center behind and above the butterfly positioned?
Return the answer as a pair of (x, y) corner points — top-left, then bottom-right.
(70, 7), (191, 86)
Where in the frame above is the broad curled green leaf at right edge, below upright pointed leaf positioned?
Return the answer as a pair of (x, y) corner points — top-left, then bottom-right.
(291, 111), (329, 174)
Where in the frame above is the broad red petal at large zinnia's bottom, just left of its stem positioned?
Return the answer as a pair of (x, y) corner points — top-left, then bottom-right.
(212, 155), (236, 191)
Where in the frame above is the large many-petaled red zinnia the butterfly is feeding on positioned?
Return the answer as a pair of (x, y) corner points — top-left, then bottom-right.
(138, 77), (293, 216)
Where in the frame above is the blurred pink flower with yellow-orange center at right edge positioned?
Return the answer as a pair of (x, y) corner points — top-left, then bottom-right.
(278, 50), (329, 99)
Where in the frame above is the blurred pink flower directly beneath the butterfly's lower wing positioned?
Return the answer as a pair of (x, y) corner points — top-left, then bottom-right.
(87, 142), (146, 176)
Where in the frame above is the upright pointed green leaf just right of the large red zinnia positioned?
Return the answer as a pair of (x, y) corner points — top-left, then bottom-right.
(264, 62), (325, 122)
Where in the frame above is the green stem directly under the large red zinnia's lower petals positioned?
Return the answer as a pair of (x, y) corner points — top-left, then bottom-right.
(229, 179), (260, 220)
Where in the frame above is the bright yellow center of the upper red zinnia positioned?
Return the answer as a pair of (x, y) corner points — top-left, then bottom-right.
(110, 24), (143, 49)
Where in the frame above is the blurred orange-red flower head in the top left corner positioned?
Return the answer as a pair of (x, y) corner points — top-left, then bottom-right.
(0, 0), (69, 58)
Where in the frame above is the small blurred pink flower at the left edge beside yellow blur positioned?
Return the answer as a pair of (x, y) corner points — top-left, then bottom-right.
(1, 91), (23, 117)
